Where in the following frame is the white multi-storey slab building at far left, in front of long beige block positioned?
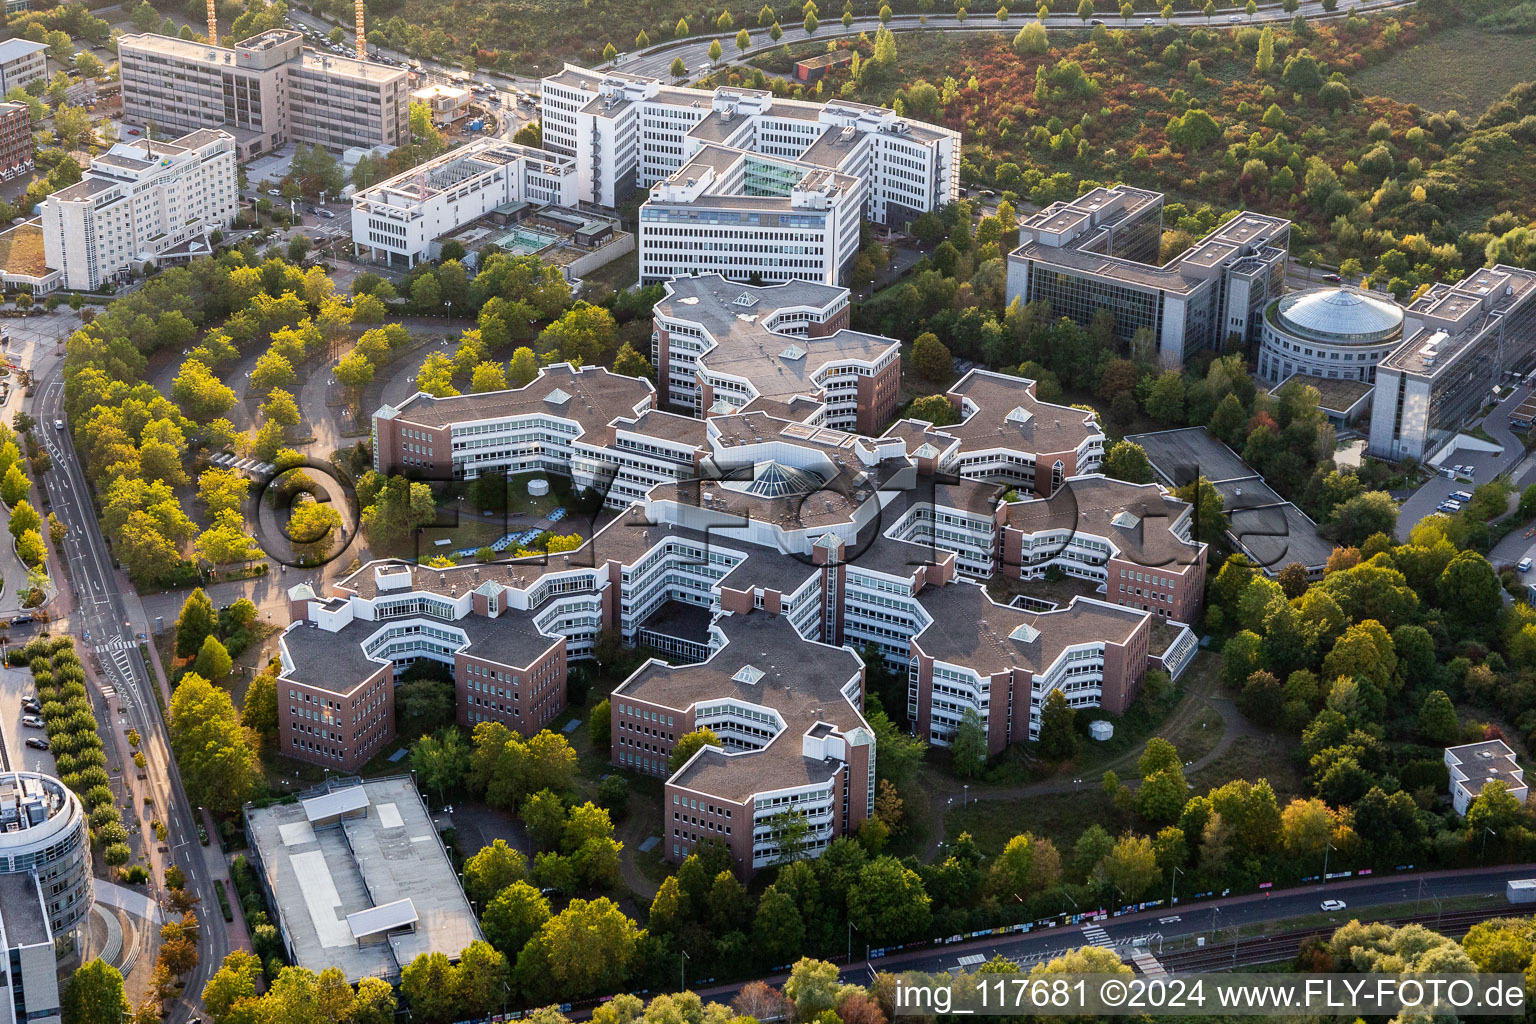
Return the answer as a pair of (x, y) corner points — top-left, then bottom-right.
(41, 130), (240, 290)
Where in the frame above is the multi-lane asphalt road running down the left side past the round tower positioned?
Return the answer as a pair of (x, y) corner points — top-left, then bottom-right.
(32, 379), (229, 1024)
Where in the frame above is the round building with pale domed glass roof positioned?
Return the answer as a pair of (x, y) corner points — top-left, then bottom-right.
(1258, 289), (1402, 384)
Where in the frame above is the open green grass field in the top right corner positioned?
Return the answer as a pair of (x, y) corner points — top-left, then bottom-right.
(1350, 25), (1536, 120)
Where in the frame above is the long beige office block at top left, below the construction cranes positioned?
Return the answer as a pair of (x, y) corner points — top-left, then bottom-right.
(117, 29), (410, 160)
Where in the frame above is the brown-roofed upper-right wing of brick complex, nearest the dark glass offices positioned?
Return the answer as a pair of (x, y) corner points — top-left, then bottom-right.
(885, 368), (1104, 497)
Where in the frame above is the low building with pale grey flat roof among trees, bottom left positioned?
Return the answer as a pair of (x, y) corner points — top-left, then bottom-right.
(246, 775), (482, 984)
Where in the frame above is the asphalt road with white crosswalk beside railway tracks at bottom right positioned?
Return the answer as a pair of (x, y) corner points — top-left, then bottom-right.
(645, 864), (1536, 1018)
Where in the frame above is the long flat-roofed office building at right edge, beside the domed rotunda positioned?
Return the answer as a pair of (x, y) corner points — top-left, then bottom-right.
(1367, 264), (1536, 461)
